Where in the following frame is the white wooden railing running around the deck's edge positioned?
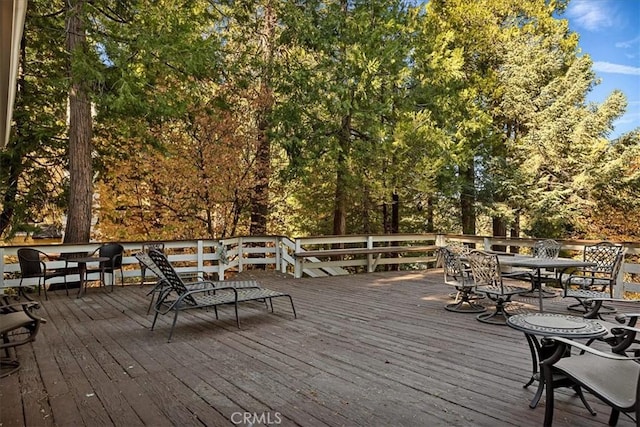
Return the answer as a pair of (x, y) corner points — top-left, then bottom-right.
(0, 233), (640, 294)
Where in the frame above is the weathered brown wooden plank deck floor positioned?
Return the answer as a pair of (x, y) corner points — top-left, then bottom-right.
(0, 270), (632, 427)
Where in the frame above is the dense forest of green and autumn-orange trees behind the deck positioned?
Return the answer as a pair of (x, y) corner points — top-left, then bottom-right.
(0, 0), (640, 247)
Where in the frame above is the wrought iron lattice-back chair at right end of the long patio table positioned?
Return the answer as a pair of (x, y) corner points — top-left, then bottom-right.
(563, 242), (624, 313)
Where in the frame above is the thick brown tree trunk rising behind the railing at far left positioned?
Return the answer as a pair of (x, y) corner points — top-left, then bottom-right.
(64, 0), (93, 243)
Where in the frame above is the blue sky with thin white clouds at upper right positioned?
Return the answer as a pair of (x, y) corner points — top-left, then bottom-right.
(561, 0), (640, 139)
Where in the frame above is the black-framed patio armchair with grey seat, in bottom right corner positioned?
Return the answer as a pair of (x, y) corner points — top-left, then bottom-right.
(541, 332), (640, 427)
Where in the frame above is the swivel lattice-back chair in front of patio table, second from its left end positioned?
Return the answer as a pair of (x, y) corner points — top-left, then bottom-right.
(468, 251), (533, 325)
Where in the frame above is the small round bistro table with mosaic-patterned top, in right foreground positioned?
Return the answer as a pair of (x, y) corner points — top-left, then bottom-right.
(507, 313), (607, 414)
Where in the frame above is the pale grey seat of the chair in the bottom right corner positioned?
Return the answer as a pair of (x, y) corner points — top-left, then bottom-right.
(554, 354), (640, 409)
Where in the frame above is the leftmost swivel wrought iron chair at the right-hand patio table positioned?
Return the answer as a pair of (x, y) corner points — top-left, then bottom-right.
(440, 246), (487, 313)
